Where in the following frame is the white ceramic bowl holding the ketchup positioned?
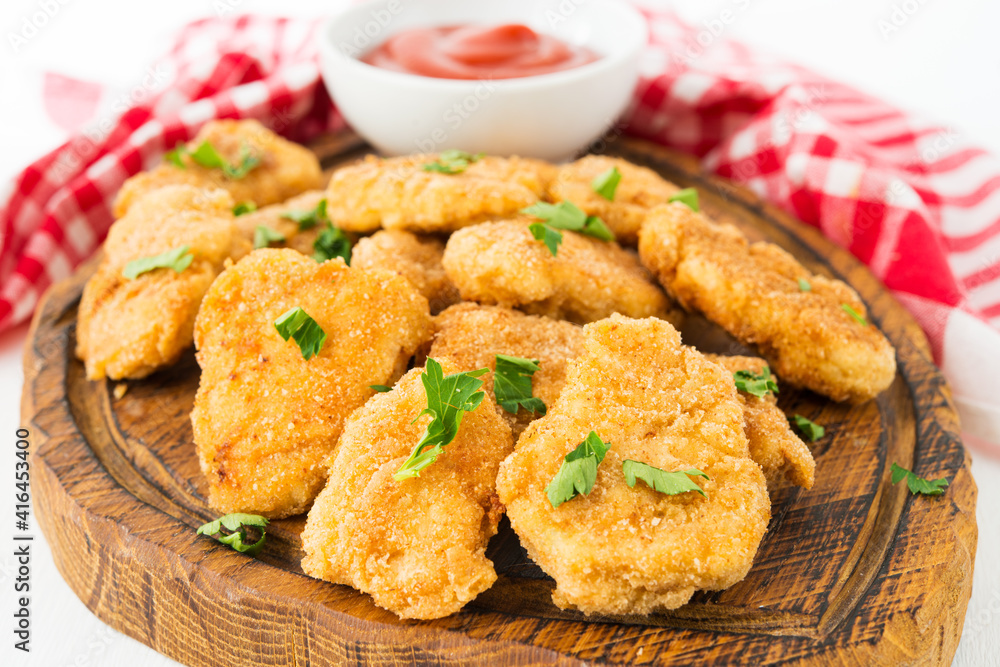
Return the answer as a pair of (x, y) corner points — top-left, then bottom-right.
(319, 0), (647, 161)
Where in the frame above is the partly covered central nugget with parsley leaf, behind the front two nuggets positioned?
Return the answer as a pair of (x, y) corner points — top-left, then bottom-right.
(428, 303), (583, 439)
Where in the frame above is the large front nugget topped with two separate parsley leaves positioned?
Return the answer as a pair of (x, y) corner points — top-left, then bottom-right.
(497, 315), (770, 614)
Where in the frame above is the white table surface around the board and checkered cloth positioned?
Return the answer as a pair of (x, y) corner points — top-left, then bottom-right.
(0, 0), (1000, 667)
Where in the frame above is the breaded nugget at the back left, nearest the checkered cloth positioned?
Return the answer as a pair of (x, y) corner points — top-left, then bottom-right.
(114, 120), (323, 218)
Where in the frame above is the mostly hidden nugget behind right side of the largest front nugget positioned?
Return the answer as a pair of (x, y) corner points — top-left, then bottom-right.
(705, 354), (816, 491)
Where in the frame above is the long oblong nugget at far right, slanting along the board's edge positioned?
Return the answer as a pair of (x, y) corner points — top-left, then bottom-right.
(639, 203), (896, 403)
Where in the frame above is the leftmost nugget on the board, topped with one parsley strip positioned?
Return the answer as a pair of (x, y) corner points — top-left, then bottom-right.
(76, 185), (248, 380)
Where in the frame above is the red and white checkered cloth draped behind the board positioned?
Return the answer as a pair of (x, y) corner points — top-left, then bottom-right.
(0, 10), (1000, 453)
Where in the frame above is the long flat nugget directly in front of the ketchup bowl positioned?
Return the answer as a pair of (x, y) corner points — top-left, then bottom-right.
(327, 154), (554, 233)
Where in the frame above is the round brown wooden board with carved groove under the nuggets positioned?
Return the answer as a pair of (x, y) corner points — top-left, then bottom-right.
(22, 134), (977, 667)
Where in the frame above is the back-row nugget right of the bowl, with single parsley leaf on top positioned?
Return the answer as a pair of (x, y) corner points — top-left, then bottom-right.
(549, 155), (680, 247)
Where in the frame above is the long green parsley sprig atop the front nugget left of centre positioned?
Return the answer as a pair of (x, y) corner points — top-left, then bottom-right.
(392, 359), (489, 482)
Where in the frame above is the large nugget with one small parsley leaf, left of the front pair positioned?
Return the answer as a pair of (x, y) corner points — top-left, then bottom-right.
(191, 249), (431, 518)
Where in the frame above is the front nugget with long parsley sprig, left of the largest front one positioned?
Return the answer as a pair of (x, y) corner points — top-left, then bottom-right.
(302, 363), (513, 619)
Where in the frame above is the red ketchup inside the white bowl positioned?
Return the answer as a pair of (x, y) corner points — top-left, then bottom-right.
(361, 23), (598, 79)
